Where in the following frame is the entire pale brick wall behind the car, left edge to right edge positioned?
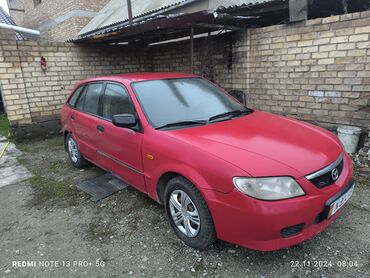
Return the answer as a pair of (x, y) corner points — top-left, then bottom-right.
(0, 12), (370, 138)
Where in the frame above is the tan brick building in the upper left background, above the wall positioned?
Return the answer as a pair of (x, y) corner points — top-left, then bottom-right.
(8, 0), (108, 41)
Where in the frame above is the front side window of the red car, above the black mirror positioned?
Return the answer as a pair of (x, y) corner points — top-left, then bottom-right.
(103, 83), (134, 120)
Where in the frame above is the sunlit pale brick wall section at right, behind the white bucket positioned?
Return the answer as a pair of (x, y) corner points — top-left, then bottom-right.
(233, 11), (370, 129)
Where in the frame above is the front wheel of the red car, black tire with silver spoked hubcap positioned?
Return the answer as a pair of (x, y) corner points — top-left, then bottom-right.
(164, 176), (217, 250)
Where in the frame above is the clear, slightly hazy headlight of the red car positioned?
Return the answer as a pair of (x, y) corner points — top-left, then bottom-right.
(233, 177), (304, 200)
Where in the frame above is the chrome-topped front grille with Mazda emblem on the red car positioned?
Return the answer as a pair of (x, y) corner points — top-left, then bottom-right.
(306, 154), (344, 188)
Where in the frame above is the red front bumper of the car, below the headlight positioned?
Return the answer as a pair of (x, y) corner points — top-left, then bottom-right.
(206, 155), (353, 251)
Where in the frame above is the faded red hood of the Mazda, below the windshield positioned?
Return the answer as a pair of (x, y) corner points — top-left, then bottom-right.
(166, 111), (343, 178)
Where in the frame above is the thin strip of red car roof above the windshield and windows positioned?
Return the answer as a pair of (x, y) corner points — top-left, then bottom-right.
(79, 72), (199, 84)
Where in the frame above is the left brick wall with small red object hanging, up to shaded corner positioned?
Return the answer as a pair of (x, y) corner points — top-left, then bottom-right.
(0, 29), (148, 134)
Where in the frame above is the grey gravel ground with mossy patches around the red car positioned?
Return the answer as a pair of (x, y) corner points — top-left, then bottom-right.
(0, 138), (370, 277)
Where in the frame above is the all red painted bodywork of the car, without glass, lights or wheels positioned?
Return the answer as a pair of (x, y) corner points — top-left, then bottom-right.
(61, 73), (352, 250)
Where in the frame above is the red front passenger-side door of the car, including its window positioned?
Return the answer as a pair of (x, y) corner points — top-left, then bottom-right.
(98, 82), (146, 192)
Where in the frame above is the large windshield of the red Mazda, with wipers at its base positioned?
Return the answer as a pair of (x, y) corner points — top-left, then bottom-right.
(132, 78), (245, 128)
